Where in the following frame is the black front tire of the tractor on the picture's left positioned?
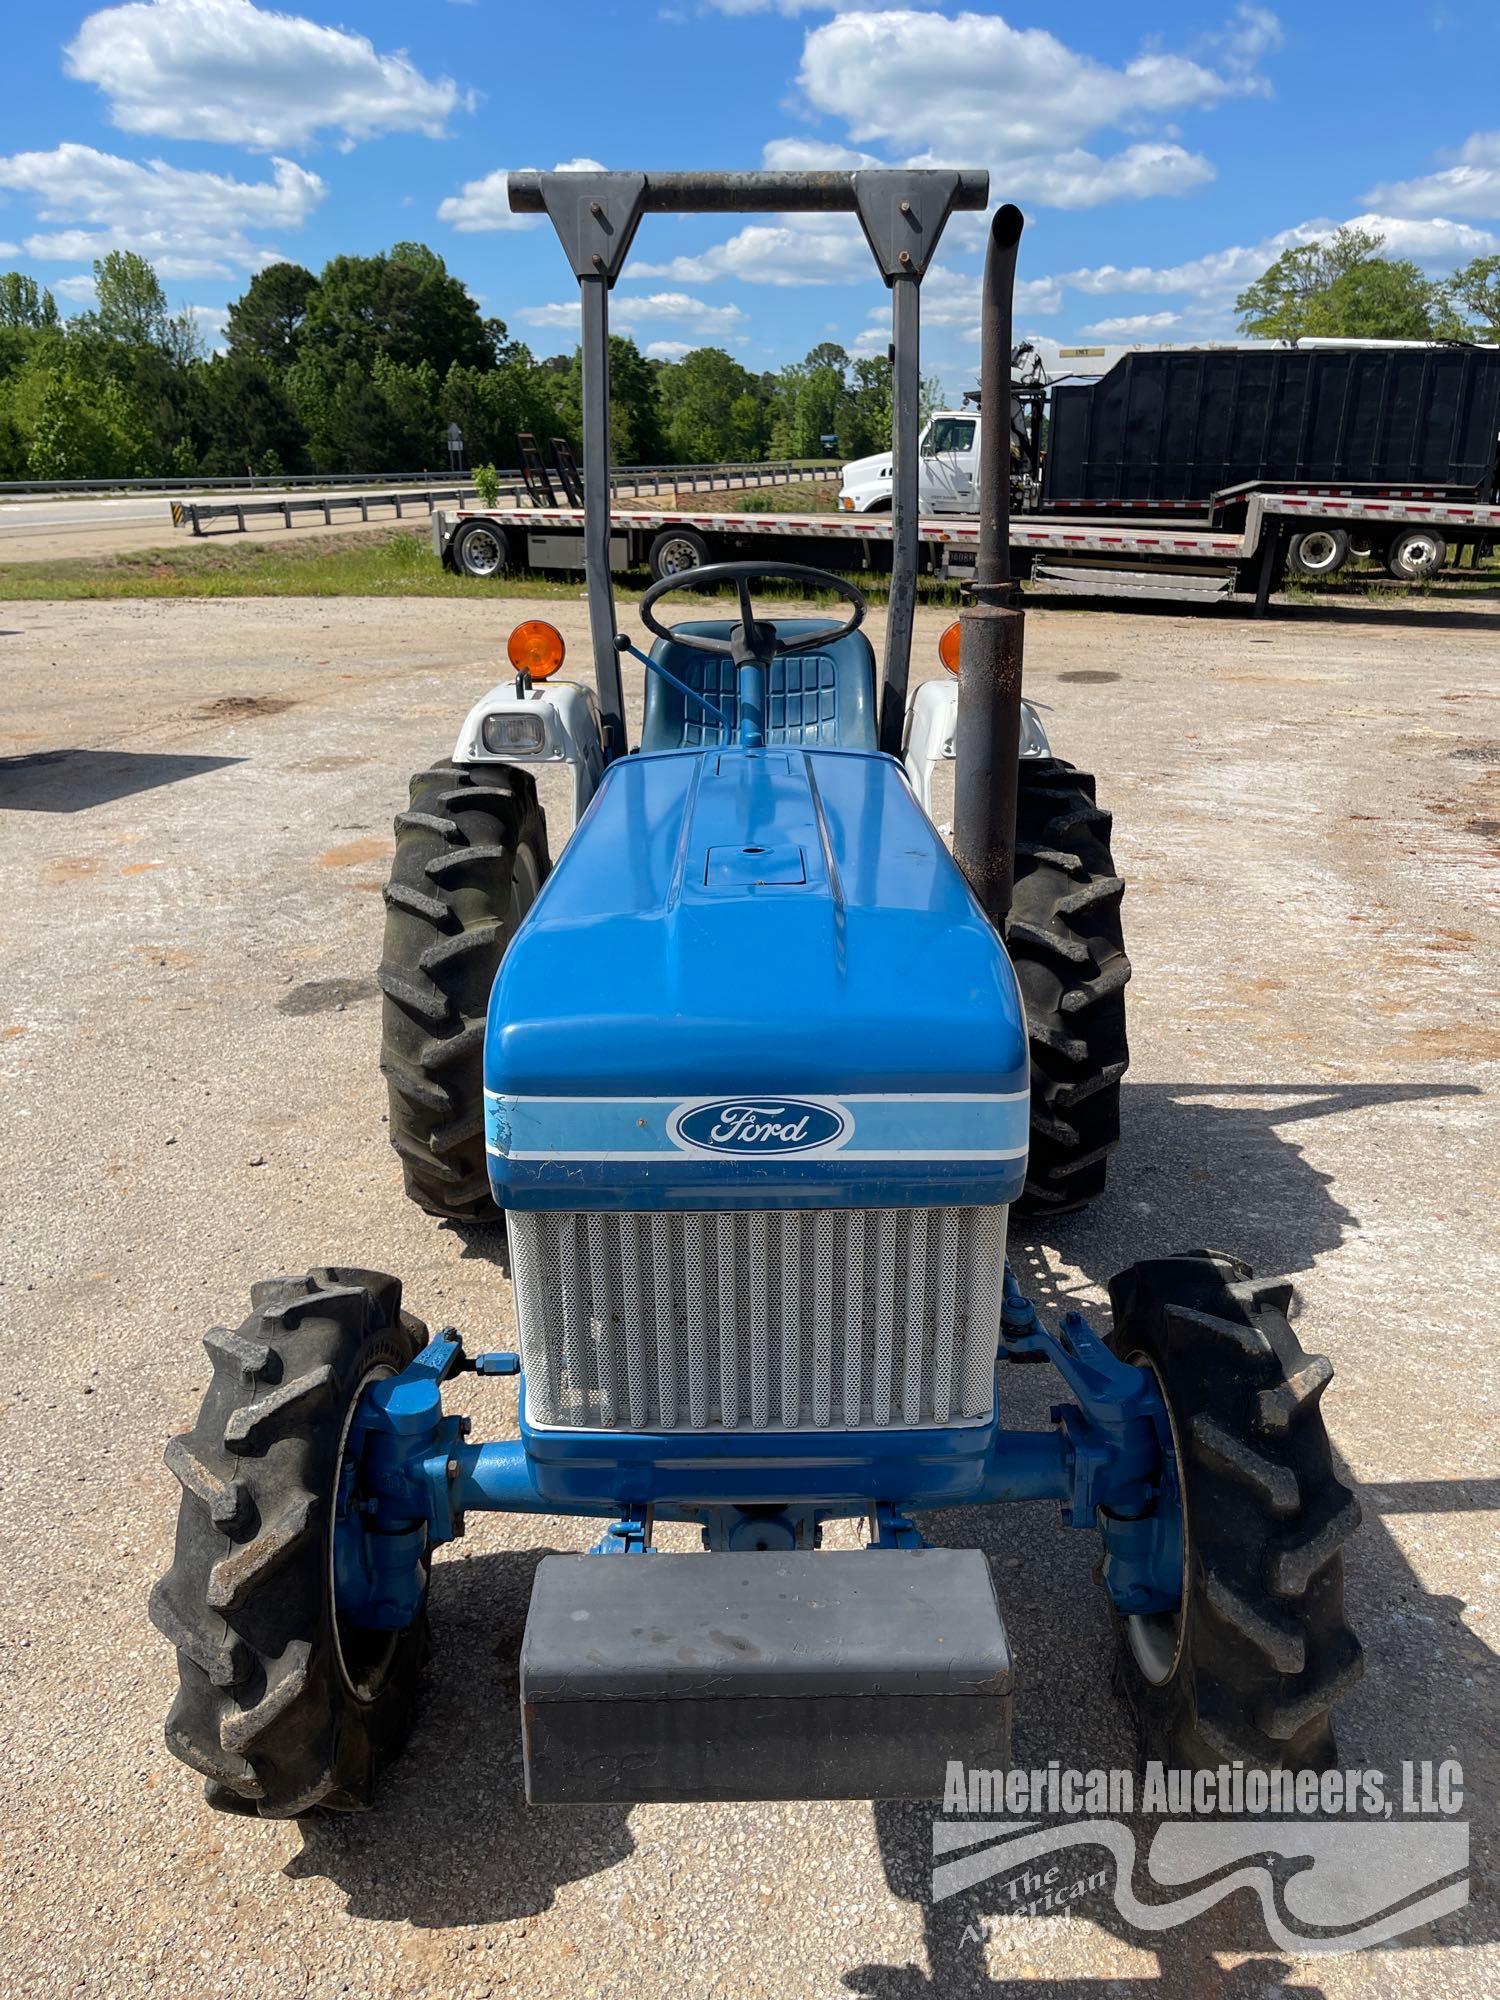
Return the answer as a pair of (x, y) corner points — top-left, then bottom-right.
(150, 1268), (428, 1820)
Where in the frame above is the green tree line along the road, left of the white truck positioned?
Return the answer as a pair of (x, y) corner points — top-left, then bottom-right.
(0, 242), (916, 480)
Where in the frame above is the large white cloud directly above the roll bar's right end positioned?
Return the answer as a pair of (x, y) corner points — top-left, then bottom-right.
(798, 10), (1266, 160)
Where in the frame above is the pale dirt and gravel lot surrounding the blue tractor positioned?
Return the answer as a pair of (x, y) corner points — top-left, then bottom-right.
(0, 592), (1500, 2000)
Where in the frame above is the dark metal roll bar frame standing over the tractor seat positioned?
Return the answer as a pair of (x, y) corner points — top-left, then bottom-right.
(510, 168), (990, 758)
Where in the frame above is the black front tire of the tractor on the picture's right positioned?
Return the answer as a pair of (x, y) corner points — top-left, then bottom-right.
(1110, 1250), (1360, 1770)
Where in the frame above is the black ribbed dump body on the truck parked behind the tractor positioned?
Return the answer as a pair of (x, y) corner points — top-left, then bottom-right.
(1040, 344), (1500, 514)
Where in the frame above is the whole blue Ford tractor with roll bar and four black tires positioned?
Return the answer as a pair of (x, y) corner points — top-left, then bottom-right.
(152, 170), (1360, 1818)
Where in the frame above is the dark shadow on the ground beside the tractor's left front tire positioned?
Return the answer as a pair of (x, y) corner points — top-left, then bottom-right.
(286, 1544), (636, 1920)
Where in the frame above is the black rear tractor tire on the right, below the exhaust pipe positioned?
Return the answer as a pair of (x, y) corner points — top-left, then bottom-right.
(1006, 758), (1130, 1214)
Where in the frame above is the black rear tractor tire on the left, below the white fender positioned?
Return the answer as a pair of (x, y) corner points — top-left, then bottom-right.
(380, 764), (552, 1222)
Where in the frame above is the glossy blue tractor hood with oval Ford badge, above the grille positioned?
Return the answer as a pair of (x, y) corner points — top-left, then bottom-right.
(484, 748), (1028, 1210)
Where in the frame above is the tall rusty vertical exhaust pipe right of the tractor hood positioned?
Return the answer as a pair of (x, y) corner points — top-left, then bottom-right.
(954, 204), (1026, 934)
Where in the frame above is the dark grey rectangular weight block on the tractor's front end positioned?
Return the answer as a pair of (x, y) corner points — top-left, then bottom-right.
(520, 1548), (1012, 1806)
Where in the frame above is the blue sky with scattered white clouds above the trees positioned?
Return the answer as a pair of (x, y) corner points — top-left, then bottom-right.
(0, 0), (1500, 396)
